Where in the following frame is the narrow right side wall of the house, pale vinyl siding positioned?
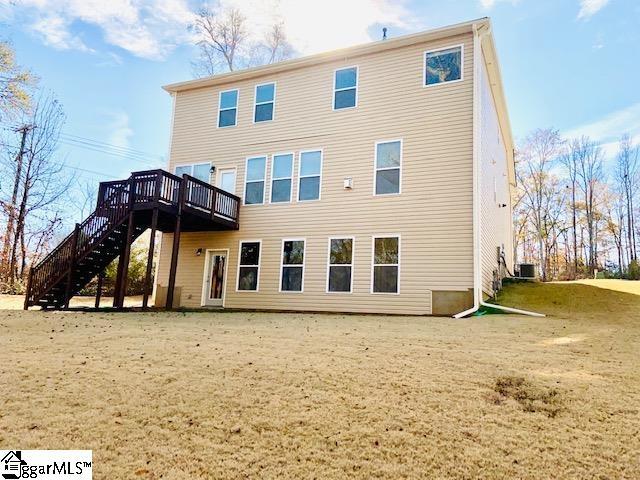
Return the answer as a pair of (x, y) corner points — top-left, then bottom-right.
(479, 44), (513, 295)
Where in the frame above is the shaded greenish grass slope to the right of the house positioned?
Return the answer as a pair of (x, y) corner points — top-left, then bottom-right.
(495, 283), (640, 321)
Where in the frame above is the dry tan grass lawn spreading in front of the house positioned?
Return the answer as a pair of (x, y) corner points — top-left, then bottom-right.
(0, 284), (640, 479)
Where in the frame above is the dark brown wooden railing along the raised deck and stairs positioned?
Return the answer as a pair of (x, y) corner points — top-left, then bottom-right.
(27, 170), (240, 304)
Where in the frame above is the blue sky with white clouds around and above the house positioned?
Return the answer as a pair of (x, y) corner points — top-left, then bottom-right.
(0, 0), (640, 185)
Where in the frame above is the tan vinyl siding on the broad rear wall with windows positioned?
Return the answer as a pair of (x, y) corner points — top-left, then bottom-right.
(157, 34), (473, 314)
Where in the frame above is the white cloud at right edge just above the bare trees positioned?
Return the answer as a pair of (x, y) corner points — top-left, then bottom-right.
(563, 102), (640, 157)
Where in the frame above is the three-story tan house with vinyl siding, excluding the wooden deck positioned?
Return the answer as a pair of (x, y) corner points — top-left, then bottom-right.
(156, 19), (513, 315)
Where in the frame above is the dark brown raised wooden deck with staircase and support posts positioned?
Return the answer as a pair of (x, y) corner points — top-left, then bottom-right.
(24, 170), (240, 309)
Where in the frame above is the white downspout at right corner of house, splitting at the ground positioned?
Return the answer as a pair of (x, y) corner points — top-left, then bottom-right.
(453, 24), (544, 318)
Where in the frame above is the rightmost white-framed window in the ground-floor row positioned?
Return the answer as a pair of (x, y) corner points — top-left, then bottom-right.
(371, 236), (400, 293)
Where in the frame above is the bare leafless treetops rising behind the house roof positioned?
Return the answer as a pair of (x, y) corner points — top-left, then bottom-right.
(190, 8), (293, 77)
